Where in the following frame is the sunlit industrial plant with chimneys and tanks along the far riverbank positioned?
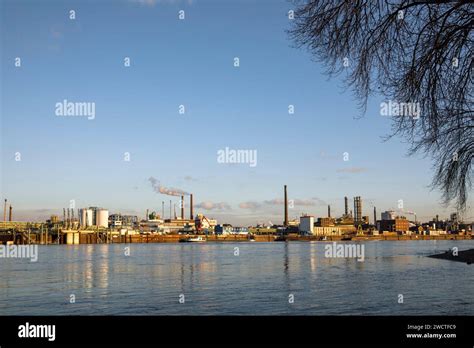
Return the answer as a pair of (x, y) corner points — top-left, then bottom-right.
(0, 185), (473, 244)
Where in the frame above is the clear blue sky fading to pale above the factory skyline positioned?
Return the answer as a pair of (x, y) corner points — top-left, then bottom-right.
(0, 0), (474, 225)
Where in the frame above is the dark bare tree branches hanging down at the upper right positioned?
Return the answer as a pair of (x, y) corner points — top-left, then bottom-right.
(290, 0), (474, 209)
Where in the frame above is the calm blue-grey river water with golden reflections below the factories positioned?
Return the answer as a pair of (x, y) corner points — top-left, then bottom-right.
(0, 241), (474, 315)
